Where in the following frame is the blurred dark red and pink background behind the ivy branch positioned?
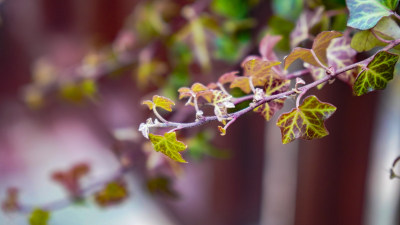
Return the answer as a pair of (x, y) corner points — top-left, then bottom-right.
(0, 0), (400, 225)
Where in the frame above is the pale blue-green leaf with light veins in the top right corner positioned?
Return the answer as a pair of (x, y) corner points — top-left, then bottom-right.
(347, 0), (397, 30)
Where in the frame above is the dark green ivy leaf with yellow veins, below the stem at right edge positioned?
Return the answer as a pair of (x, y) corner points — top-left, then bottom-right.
(353, 51), (399, 96)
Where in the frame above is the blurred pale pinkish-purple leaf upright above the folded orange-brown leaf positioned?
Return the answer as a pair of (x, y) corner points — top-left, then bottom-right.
(290, 7), (324, 48)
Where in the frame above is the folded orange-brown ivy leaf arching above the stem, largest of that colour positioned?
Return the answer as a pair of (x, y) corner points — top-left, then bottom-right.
(284, 31), (343, 70)
